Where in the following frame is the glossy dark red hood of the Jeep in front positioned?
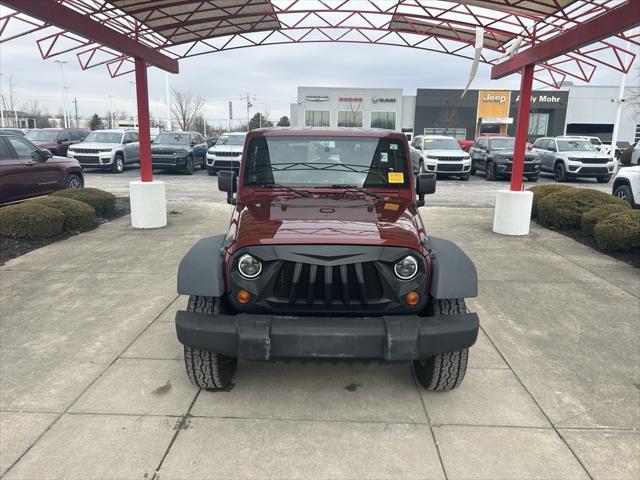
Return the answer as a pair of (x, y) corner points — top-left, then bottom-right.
(230, 196), (425, 251)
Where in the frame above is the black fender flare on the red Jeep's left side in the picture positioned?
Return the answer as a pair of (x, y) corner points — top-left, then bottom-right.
(178, 235), (226, 297)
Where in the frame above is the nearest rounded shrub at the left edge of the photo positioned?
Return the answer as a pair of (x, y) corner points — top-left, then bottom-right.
(0, 202), (64, 240)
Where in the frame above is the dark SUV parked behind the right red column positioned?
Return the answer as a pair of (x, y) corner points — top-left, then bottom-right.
(469, 136), (540, 182)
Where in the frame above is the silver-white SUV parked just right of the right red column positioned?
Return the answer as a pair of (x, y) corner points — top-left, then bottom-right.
(532, 137), (616, 183)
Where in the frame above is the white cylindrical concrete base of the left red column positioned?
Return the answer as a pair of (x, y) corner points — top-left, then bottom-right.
(129, 180), (167, 228)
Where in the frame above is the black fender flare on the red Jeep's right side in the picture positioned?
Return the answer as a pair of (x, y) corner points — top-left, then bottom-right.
(426, 236), (478, 299)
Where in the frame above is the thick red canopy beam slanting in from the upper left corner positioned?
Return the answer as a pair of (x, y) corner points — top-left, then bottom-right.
(0, 0), (179, 73)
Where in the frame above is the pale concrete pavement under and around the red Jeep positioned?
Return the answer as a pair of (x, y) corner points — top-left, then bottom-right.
(0, 203), (640, 480)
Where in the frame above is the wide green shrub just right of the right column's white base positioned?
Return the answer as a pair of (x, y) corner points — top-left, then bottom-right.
(537, 188), (626, 230)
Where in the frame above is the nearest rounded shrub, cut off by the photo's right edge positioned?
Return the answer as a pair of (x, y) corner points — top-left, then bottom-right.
(593, 210), (640, 252)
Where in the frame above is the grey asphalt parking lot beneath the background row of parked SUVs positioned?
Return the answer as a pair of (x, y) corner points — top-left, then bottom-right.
(85, 167), (611, 208)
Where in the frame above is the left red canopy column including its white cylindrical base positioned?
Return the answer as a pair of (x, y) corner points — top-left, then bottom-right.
(129, 57), (167, 228)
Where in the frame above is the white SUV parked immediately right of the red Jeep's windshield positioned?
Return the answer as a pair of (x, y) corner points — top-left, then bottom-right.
(411, 135), (471, 181)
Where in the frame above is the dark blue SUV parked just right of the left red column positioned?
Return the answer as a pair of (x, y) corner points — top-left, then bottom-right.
(151, 132), (207, 175)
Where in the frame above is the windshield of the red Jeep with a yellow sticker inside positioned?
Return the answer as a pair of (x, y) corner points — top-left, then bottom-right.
(243, 137), (409, 188)
